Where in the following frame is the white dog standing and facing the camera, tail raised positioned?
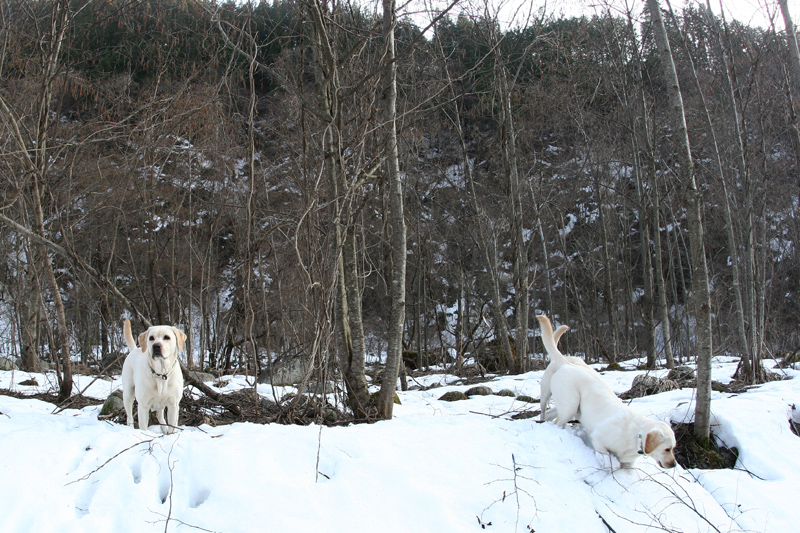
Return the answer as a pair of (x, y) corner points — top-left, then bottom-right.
(122, 318), (186, 433)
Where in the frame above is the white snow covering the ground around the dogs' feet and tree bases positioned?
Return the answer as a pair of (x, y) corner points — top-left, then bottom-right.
(0, 359), (800, 533)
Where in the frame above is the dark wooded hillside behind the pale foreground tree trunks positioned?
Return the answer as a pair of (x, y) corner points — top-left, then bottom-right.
(0, 0), (800, 400)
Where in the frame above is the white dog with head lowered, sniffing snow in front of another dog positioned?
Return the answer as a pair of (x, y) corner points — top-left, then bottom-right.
(537, 317), (675, 468)
